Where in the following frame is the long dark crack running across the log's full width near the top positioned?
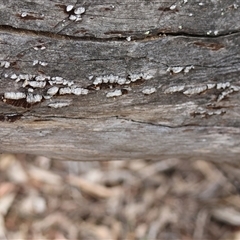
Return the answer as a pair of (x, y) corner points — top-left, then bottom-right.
(0, 25), (240, 42)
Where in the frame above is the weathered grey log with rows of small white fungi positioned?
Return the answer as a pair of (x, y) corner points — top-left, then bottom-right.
(0, 0), (240, 161)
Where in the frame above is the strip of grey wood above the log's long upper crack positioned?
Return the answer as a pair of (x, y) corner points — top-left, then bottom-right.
(0, 0), (240, 39)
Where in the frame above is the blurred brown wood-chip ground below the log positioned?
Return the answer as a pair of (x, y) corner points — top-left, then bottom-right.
(0, 154), (240, 240)
